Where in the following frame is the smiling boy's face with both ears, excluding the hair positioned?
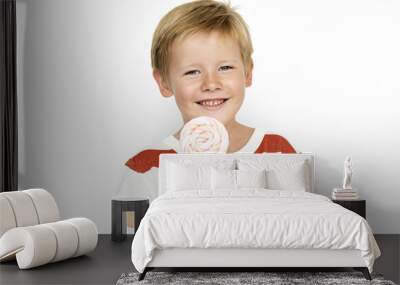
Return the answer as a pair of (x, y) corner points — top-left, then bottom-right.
(153, 29), (252, 125)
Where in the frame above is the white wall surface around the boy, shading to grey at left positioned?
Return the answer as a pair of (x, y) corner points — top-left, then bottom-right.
(17, 0), (400, 234)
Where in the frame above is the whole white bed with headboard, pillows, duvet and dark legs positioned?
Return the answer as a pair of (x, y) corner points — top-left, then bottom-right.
(132, 154), (380, 280)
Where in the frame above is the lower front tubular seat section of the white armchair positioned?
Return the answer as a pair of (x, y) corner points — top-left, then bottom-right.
(0, 218), (98, 269)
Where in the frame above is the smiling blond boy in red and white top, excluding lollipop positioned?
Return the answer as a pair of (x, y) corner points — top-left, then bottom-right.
(120, 0), (295, 200)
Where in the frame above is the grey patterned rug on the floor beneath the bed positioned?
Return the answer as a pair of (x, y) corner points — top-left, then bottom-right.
(116, 271), (395, 285)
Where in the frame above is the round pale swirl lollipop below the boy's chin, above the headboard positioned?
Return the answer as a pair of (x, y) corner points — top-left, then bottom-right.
(180, 116), (229, 153)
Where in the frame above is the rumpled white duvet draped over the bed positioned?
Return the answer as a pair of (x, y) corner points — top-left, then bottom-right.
(132, 189), (380, 272)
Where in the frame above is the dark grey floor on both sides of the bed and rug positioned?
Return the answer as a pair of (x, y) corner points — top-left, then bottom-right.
(0, 235), (400, 285)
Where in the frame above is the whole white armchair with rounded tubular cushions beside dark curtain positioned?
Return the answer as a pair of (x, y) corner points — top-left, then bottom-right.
(0, 189), (98, 269)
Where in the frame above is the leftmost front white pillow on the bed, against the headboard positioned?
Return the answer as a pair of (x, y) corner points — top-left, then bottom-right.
(166, 163), (211, 191)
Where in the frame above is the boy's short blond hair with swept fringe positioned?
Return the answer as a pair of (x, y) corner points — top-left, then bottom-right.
(151, 0), (253, 81)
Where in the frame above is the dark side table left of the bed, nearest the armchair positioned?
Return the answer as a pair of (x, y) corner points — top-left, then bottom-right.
(111, 197), (149, 241)
